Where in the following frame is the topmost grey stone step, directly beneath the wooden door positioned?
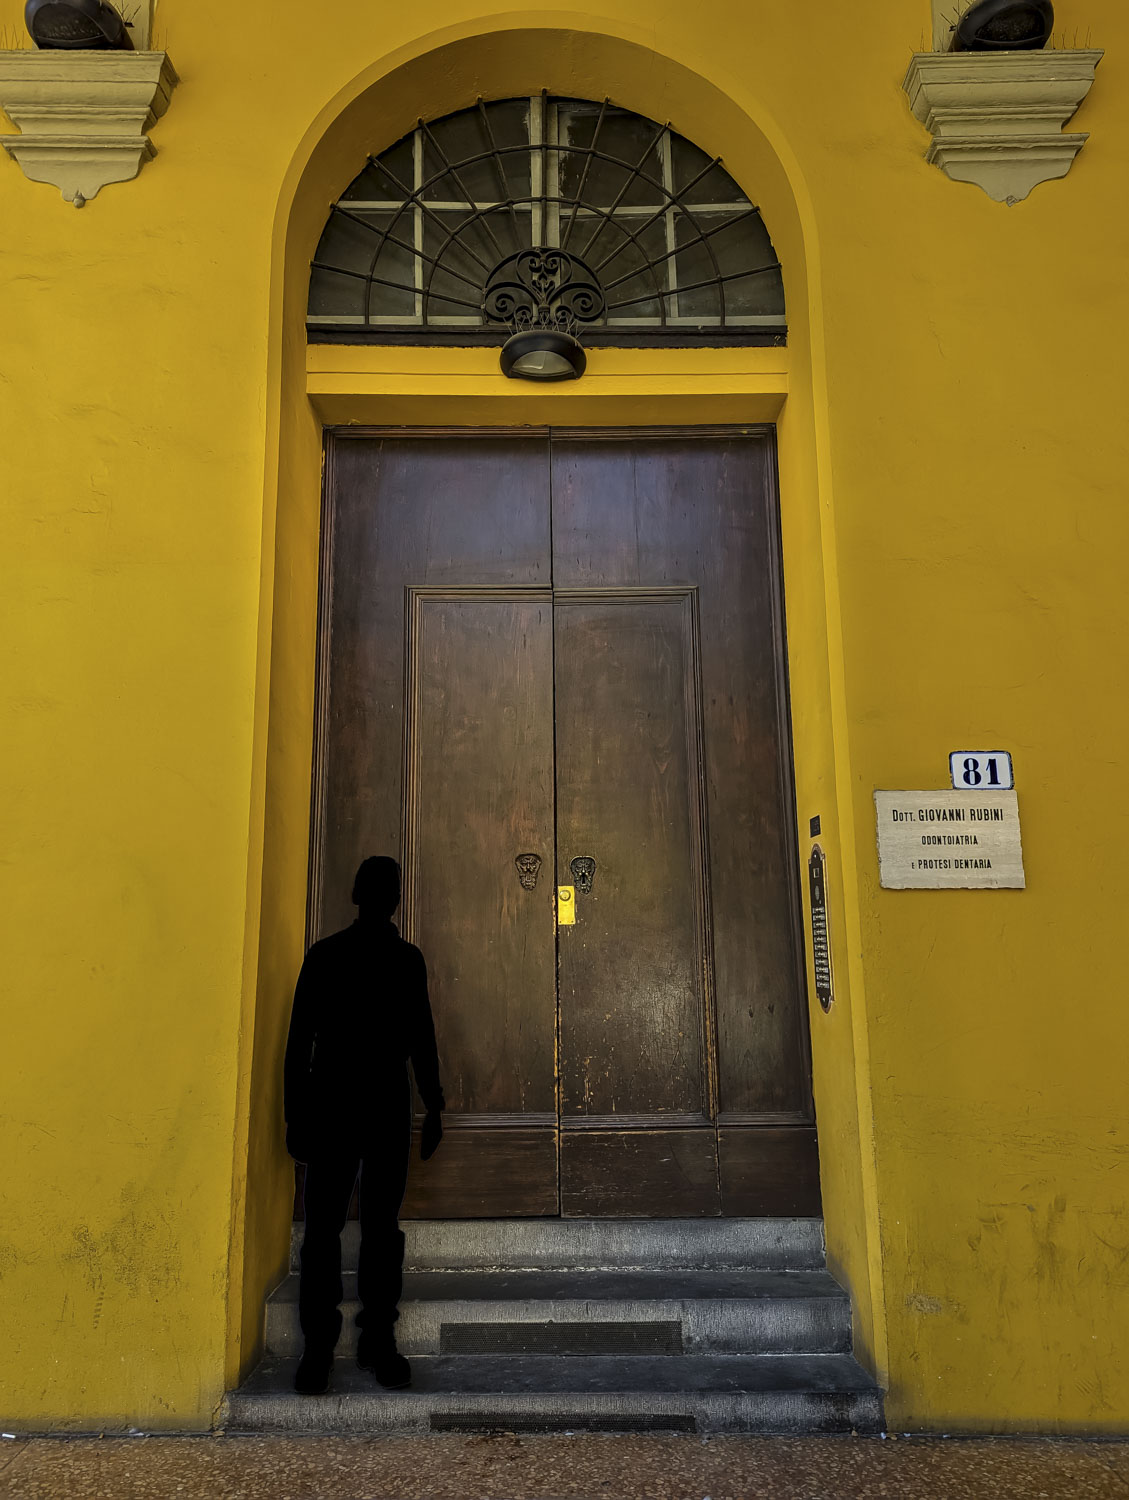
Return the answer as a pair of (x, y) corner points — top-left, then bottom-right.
(291, 1218), (823, 1271)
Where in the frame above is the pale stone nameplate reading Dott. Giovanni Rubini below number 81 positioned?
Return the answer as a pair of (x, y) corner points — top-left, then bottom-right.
(874, 791), (1027, 891)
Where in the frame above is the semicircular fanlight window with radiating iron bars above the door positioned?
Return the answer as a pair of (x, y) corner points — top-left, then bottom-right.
(307, 95), (784, 342)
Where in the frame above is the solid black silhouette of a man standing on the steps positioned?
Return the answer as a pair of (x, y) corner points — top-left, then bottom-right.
(285, 857), (445, 1395)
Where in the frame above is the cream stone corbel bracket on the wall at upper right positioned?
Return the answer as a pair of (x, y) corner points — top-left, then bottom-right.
(903, 50), (1102, 204)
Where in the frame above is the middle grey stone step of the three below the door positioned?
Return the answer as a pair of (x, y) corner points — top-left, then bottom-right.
(265, 1271), (850, 1358)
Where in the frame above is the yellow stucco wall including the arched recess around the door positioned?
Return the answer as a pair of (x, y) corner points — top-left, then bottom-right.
(0, 0), (1129, 1431)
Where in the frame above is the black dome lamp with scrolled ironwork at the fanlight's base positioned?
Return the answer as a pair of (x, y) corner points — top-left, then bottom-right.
(483, 246), (606, 381)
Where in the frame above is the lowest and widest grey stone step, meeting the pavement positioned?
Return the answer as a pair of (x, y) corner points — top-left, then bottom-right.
(220, 1355), (882, 1434)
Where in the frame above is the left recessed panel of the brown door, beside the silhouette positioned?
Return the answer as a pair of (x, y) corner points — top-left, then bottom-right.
(403, 590), (556, 1115)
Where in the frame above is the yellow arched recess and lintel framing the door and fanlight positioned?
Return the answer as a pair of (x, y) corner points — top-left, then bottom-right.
(232, 18), (870, 1404)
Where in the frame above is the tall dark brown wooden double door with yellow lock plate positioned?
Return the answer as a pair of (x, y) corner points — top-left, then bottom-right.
(312, 429), (819, 1218)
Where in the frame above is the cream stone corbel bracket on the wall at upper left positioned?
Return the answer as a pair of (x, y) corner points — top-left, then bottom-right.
(0, 48), (178, 209)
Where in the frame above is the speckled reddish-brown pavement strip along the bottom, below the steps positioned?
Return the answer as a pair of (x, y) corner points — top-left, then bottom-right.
(0, 1434), (1129, 1500)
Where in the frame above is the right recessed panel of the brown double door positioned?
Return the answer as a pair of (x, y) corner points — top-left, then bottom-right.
(555, 590), (712, 1119)
